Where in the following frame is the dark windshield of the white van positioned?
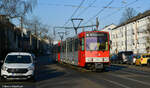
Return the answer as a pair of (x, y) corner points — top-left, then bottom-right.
(5, 55), (32, 64)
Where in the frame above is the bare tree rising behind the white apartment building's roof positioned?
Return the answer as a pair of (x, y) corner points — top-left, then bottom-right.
(120, 8), (137, 24)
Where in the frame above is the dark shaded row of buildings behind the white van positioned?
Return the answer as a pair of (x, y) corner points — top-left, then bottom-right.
(0, 15), (50, 60)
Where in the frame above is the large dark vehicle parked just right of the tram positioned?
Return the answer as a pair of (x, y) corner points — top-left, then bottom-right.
(117, 51), (133, 64)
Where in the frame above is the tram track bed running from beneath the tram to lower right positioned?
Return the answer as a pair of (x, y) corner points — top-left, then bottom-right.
(57, 64), (150, 88)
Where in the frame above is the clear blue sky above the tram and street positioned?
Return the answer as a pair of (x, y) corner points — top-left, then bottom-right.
(25, 0), (150, 39)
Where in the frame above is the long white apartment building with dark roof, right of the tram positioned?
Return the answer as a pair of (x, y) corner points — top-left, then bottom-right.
(111, 11), (150, 53)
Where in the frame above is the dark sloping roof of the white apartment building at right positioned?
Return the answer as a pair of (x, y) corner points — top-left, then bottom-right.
(114, 10), (150, 29)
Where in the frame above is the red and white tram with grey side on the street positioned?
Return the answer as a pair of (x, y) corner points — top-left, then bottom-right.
(54, 31), (110, 70)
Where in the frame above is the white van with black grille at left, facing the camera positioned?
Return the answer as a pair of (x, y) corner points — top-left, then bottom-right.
(1, 52), (35, 80)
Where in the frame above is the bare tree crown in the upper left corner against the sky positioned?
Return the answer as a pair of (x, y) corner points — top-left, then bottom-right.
(0, 0), (37, 18)
